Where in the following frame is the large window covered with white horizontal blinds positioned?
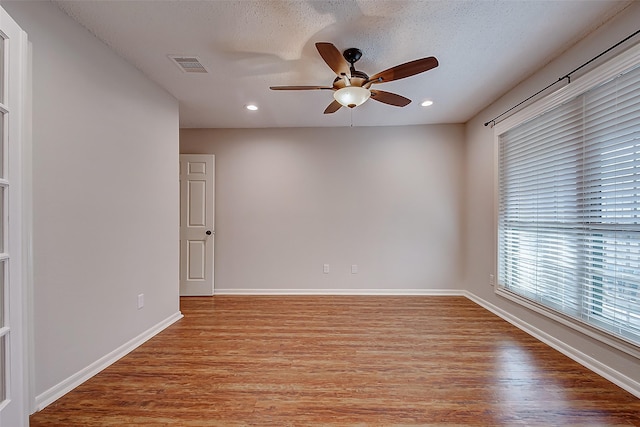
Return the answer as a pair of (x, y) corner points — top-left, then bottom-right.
(496, 46), (640, 354)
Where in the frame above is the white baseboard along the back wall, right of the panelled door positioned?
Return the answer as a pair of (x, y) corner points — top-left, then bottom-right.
(214, 288), (466, 296)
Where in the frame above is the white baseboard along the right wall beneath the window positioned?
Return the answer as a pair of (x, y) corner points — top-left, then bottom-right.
(464, 291), (640, 398)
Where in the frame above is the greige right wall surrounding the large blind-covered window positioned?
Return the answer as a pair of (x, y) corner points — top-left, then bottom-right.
(464, 2), (640, 392)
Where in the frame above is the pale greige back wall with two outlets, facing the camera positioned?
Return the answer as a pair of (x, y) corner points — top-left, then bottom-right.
(180, 125), (464, 293)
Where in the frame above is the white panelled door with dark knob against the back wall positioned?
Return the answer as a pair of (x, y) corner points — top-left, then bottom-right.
(180, 154), (215, 296)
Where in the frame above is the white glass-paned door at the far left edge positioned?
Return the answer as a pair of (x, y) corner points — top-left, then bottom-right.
(0, 8), (29, 427)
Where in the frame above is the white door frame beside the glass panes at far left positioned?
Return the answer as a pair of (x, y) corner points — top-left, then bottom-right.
(0, 7), (34, 426)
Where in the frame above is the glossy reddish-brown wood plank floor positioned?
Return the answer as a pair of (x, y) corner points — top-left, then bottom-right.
(30, 296), (640, 427)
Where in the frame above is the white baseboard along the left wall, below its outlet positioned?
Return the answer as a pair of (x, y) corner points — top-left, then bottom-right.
(35, 311), (183, 411)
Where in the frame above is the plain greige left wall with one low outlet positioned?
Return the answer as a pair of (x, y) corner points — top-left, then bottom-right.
(3, 2), (179, 408)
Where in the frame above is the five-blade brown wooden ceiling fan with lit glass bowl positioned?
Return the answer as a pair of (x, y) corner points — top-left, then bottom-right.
(270, 42), (438, 114)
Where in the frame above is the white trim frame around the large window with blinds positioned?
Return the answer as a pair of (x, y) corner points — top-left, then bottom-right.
(493, 43), (640, 359)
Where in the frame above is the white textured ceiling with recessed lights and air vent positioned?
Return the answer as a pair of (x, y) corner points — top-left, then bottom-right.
(55, 0), (631, 128)
